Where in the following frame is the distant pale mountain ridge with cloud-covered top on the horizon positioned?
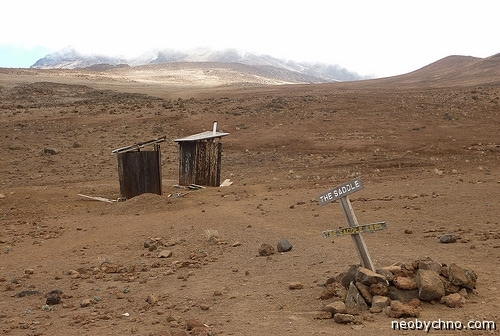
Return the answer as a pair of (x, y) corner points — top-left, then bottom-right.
(31, 47), (366, 83)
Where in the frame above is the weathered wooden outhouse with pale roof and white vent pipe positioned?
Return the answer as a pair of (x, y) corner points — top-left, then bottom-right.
(174, 122), (229, 187)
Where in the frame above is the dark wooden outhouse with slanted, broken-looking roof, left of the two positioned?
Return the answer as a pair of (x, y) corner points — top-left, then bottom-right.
(113, 137), (165, 199)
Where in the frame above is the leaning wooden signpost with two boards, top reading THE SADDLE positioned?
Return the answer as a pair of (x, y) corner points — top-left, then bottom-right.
(318, 177), (386, 272)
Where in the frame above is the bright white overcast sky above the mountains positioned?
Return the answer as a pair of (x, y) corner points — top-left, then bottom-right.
(0, 0), (500, 77)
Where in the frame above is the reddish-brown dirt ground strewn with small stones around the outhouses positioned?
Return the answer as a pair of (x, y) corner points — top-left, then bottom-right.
(0, 64), (500, 336)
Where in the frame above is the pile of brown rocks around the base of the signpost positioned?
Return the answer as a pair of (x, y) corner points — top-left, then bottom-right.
(320, 259), (477, 323)
